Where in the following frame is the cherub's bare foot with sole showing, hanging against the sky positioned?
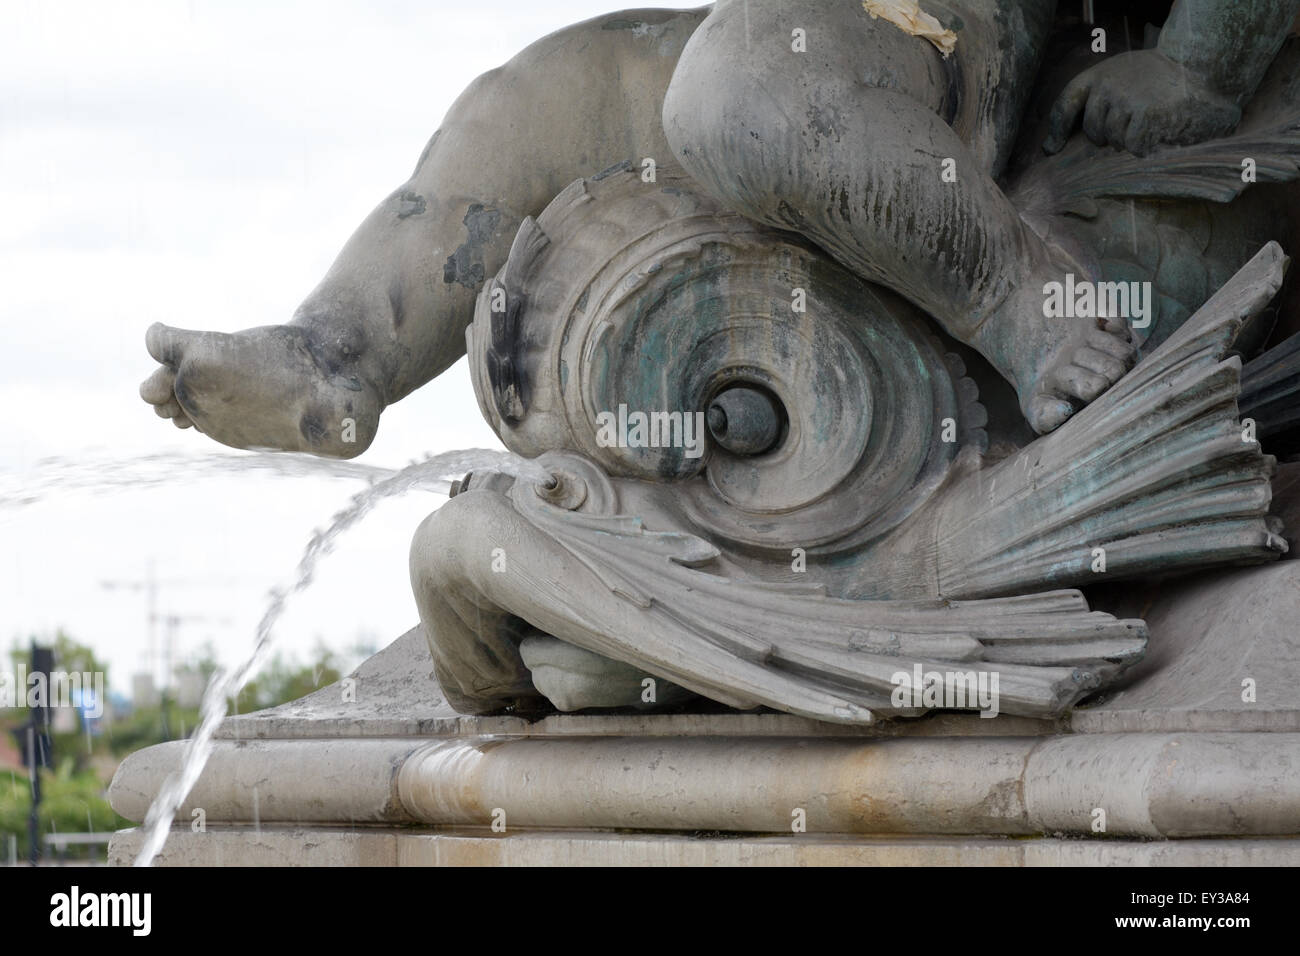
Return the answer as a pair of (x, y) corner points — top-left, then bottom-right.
(140, 323), (384, 458)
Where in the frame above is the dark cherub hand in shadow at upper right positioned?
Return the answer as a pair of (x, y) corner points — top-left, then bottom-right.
(1043, 49), (1242, 156)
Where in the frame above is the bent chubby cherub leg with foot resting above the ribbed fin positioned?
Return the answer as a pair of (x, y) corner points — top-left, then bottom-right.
(664, 0), (1131, 432)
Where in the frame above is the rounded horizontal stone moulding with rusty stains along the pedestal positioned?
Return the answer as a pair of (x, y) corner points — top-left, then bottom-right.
(109, 734), (1300, 838)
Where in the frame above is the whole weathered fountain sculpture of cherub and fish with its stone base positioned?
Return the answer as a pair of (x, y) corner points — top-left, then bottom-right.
(113, 0), (1300, 862)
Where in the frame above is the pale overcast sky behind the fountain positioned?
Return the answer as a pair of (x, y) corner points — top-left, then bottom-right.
(0, 0), (690, 691)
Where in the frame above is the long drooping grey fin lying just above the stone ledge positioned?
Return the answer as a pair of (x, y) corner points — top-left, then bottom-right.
(511, 481), (1147, 723)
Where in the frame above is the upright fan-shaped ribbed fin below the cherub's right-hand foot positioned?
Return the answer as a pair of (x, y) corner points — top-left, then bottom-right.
(937, 243), (1287, 597)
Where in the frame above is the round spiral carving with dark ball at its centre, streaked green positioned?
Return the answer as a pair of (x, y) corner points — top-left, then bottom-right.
(467, 165), (984, 554)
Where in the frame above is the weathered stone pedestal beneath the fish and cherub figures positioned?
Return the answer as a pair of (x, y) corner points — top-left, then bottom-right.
(109, 561), (1300, 866)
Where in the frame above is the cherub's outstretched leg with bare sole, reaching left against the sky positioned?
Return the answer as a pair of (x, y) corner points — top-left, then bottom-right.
(140, 10), (707, 458)
